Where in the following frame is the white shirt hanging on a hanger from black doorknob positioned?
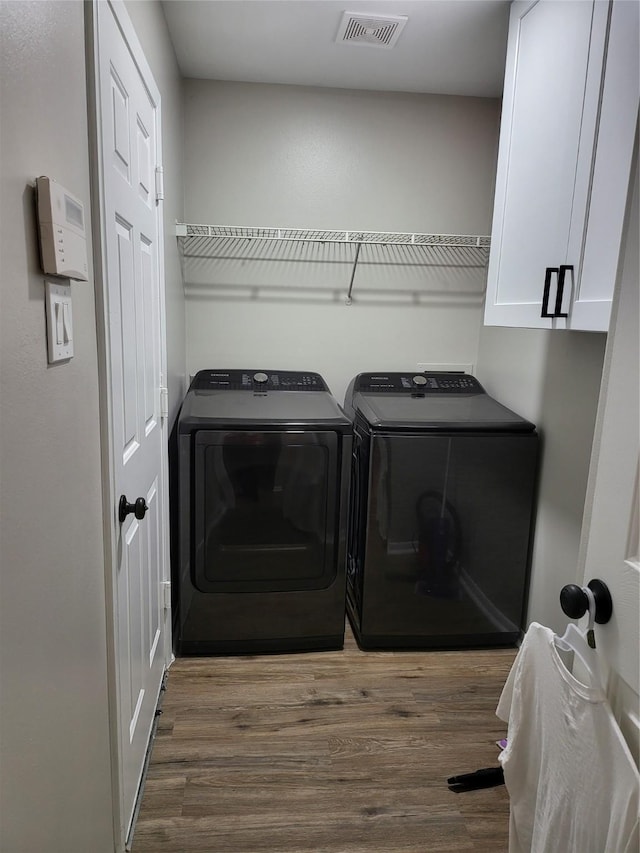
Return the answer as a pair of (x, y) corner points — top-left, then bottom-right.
(496, 622), (640, 853)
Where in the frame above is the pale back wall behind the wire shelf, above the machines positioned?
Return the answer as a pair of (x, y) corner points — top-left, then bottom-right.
(180, 80), (499, 399)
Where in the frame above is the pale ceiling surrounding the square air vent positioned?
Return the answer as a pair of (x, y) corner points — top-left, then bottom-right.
(163, 0), (510, 97)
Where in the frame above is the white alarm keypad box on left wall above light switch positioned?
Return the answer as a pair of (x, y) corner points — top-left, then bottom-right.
(36, 177), (89, 281)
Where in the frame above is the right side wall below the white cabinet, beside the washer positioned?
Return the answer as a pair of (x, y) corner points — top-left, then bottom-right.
(478, 326), (606, 633)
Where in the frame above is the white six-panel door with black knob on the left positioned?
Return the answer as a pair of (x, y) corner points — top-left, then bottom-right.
(85, 0), (171, 851)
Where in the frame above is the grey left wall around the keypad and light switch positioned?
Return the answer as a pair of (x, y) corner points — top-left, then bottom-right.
(0, 0), (113, 853)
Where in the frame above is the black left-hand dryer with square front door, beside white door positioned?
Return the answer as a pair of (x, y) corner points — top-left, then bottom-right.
(175, 370), (352, 654)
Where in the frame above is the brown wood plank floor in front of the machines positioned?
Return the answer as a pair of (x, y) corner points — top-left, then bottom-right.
(132, 628), (515, 853)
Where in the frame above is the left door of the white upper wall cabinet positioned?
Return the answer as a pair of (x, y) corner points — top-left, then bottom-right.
(485, 0), (609, 328)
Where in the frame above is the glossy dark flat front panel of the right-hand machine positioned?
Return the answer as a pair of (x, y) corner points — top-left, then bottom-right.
(360, 433), (538, 645)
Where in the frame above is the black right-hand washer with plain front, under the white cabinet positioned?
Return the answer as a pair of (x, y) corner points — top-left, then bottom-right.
(345, 372), (538, 648)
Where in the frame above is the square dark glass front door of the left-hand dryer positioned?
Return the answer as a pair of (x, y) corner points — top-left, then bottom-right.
(193, 430), (339, 593)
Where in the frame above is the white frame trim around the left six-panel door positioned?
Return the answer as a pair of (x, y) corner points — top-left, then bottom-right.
(85, 0), (172, 840)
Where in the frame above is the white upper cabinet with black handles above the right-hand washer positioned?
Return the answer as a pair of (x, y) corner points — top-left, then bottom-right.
(485, 0), (640, 331)
